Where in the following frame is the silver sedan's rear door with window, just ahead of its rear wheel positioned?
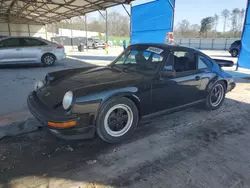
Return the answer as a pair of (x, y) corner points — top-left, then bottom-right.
(21, 37), (47, 63)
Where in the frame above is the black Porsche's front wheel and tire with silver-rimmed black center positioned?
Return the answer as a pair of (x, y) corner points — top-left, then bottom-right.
(96, 97), (139, 144)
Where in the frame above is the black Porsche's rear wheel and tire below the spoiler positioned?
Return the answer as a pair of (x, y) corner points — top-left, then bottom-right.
(205, 82), (226, 110)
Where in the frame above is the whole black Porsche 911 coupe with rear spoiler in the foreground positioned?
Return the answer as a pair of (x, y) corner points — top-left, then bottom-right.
(27, 44), (235, 143)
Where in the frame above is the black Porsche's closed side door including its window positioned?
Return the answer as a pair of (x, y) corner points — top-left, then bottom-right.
(152, 49), (201, 111)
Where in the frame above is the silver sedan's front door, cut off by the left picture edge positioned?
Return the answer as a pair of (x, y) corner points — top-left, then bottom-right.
(0, 38), (22, 64)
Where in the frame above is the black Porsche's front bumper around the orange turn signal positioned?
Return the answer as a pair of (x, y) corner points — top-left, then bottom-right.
(27, 92), (95, 139)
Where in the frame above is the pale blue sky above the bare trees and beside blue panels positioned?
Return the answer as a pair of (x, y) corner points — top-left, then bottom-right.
(91, 0), (247, 31)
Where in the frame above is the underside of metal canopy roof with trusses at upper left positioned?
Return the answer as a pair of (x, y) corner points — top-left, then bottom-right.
(0, 0), (132, 24)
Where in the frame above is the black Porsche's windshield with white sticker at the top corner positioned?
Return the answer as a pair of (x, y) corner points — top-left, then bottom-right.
(111, 46), (164, 74)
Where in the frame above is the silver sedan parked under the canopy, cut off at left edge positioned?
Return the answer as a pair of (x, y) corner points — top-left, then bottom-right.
(0, 37), (66, 66)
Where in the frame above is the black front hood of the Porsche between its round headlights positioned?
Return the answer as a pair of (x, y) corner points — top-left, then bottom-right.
(36, 67), (145, 108)
